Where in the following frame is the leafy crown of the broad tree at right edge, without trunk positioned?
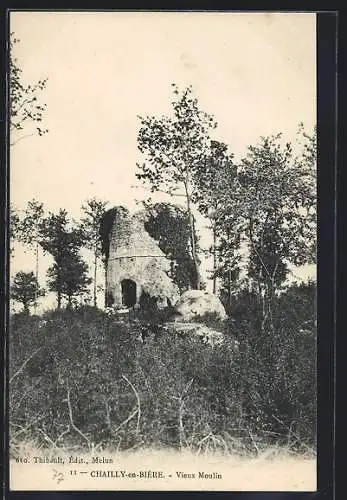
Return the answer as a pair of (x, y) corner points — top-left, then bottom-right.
(242, 131), (316, 276)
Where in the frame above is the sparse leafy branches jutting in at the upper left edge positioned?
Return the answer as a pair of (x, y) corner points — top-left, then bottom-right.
(9, 33), (48, 146)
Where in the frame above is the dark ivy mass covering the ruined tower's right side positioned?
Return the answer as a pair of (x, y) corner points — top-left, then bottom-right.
(141, 203), (197, 293)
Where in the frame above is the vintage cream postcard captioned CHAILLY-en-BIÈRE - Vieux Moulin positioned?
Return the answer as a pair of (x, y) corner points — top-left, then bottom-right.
(9, 11), (317, 492)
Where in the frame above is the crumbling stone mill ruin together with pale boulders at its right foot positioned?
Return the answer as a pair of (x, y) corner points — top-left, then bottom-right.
(101, 206), (231, 346)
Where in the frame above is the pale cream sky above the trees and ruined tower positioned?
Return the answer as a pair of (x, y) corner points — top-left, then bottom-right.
(10, 12), (316, 308)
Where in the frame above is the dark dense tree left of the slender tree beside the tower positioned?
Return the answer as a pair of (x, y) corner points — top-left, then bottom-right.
(40, 209), (90, 309)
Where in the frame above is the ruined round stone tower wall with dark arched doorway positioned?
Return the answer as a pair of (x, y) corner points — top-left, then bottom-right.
(106, 207), (179, 308)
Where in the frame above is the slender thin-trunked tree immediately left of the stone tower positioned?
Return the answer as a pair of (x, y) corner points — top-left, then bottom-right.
(81, 198), (108, 307)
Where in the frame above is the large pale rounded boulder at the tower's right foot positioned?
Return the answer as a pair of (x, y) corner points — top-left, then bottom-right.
(174, 290), (227, 322)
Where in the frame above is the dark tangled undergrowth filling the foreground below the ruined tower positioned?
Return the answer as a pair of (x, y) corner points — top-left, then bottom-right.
(10, 284), (316, 454)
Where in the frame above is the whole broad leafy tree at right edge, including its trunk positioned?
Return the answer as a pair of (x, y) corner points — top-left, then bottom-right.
(219, 130), (316, 328)
